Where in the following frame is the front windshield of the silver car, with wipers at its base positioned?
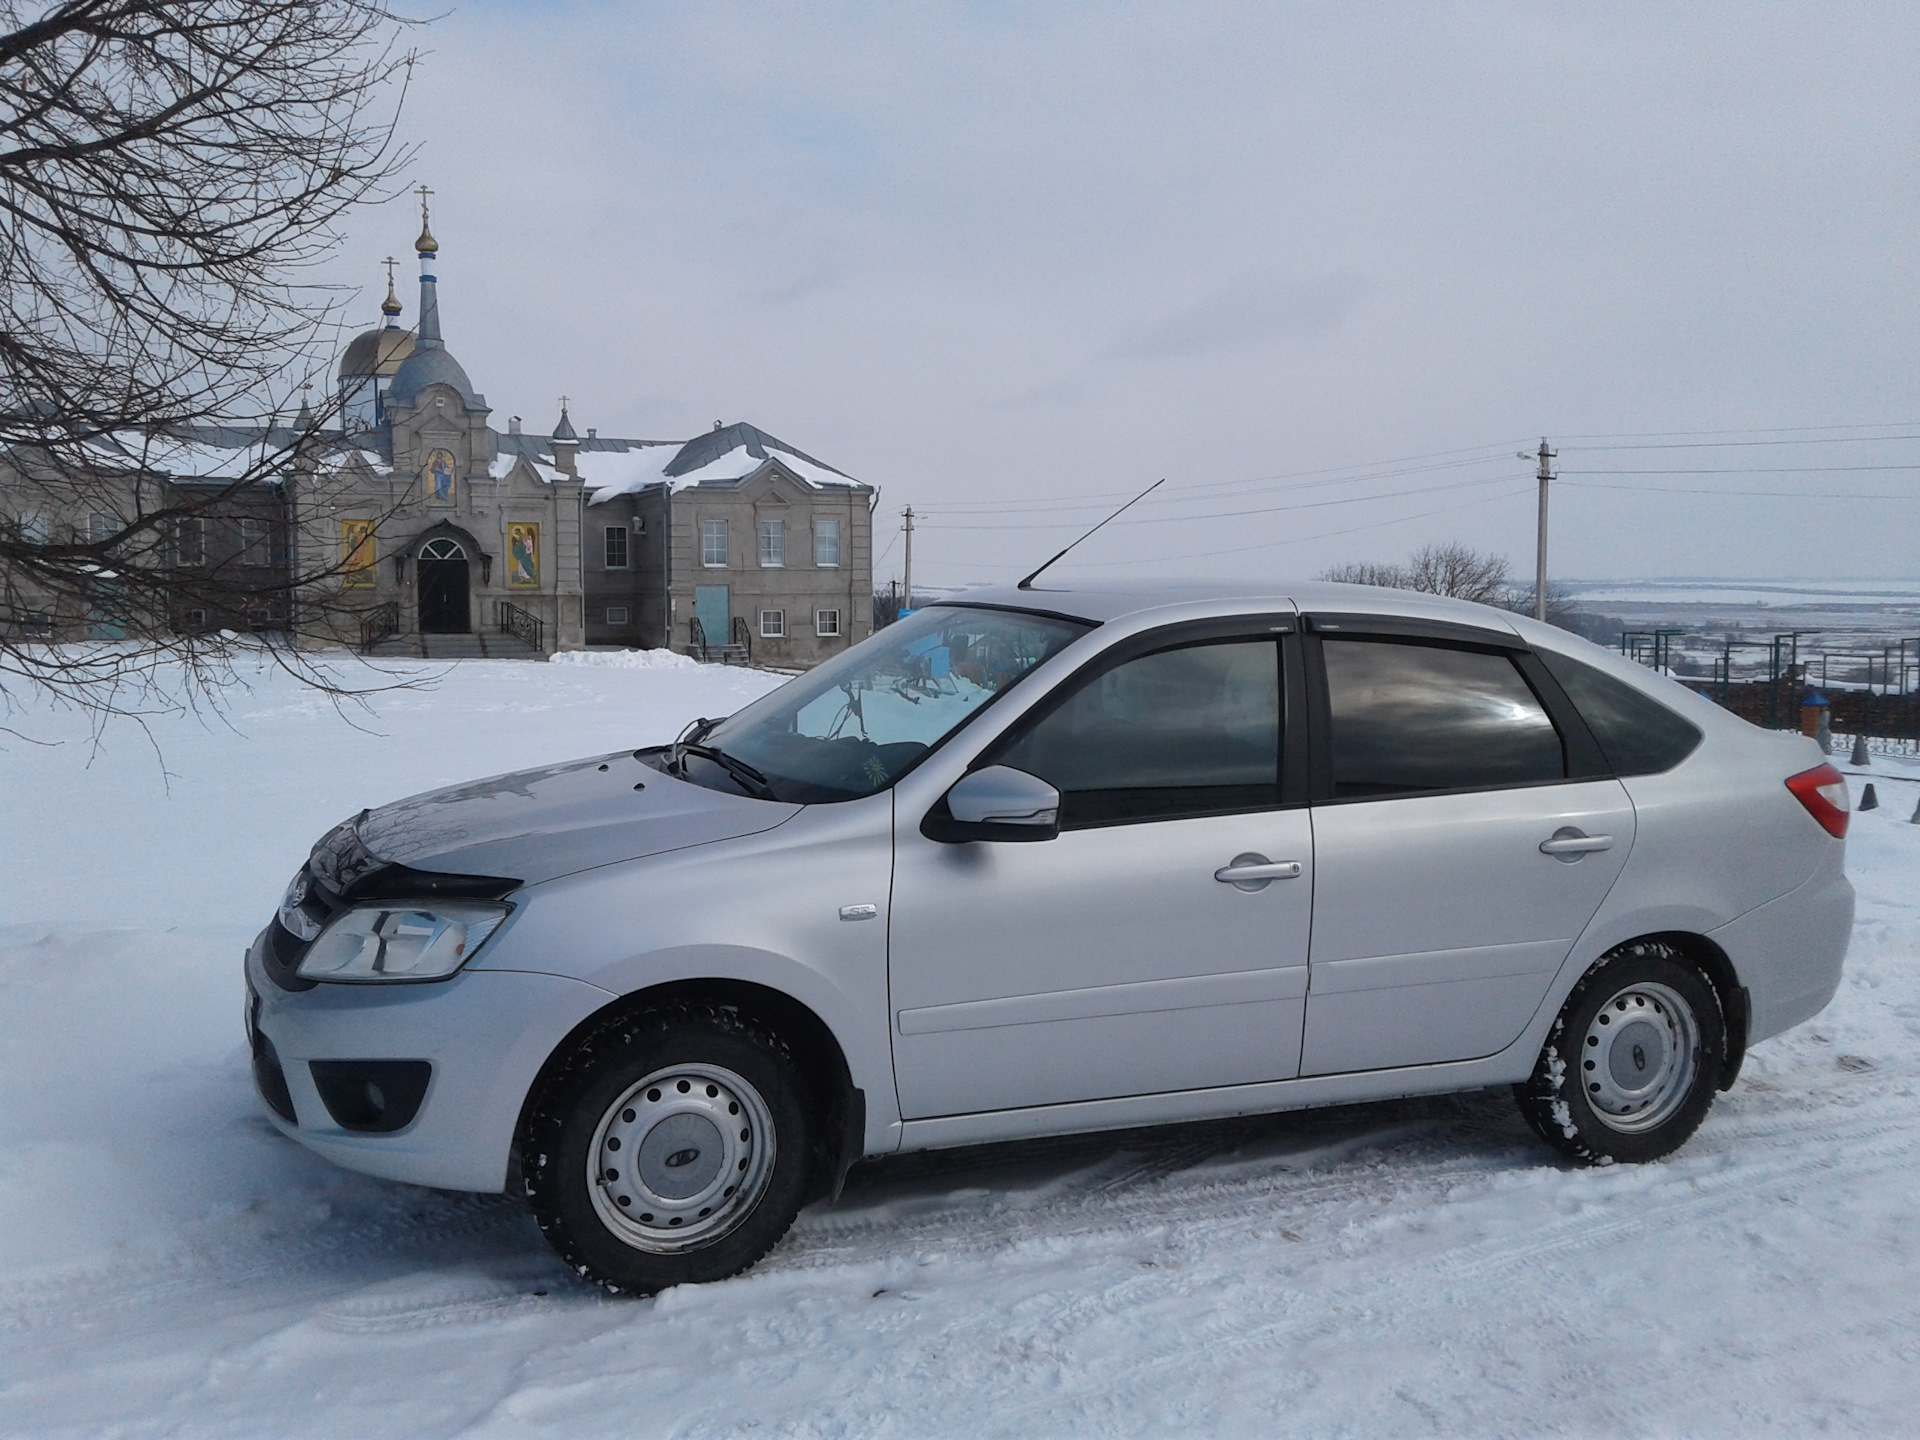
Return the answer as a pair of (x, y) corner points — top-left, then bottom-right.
(685, 605), (1091, 804)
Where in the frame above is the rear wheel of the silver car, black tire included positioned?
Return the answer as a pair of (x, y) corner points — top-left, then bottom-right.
(1513, 941), (1726, 1165)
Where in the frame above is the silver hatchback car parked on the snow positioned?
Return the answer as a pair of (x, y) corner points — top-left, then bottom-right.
(246, 586), (1853, 1292)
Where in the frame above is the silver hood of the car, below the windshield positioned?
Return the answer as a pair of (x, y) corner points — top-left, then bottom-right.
(357, 751), (801, 885)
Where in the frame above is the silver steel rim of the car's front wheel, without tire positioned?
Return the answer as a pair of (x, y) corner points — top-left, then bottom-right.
(588, 1066), (774, 1254)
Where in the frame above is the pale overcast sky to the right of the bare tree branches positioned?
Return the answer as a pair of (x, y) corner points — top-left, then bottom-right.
(322, 2), (1920, 586)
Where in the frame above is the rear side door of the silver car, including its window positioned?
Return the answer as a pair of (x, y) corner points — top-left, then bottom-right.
(1302, 616), (1634, 1075)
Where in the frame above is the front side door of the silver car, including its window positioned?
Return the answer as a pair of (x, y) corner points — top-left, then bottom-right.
(889, 616), (1313, 1119)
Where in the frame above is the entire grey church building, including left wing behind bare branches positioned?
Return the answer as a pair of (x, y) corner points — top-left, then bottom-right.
(0, 194), (879, 668)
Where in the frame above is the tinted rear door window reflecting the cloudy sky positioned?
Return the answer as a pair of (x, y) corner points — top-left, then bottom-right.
(1321, 637), (1567, 801)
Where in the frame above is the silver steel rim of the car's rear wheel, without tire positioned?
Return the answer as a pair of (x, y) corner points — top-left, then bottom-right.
(1580, 983), (1699, 1135)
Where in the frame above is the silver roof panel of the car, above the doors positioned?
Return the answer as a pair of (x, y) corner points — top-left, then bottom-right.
(931, 580), (1517, 634)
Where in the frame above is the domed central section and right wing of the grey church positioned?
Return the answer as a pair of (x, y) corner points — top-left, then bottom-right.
(316, 205), (879, 668)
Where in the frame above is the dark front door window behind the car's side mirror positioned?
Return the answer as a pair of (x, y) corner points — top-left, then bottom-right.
(996, 637), (1281, 829)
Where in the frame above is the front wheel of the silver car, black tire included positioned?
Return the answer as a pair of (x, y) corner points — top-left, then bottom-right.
(520, 1006), (812, 1294)
